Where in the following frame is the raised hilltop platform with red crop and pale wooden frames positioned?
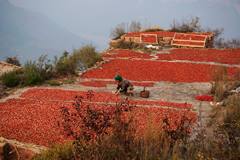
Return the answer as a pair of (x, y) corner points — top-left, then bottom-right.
(116, 31), (214, 48)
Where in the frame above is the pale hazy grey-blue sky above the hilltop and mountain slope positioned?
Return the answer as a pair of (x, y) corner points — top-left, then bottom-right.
(9, 0), (240, 48)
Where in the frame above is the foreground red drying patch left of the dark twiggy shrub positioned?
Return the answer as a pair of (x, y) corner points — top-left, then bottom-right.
(0, 99), (67, 145)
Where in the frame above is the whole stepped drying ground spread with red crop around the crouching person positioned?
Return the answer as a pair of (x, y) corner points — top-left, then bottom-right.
(0, 49), (240, 146)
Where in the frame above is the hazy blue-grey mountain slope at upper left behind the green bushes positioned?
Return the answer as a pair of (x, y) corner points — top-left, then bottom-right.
(0, 0), (87, 61)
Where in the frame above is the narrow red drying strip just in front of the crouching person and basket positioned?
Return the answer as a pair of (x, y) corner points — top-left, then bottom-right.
(21, 88), (192, 109)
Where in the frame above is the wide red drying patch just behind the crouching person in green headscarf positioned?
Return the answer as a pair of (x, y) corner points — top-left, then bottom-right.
(82, 59), (237, 82)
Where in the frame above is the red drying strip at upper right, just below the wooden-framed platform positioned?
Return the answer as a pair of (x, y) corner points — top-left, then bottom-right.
(158, 49), (240, 64)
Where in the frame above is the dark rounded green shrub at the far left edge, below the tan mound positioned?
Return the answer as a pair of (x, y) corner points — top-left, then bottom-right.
(1, 71), (21, 87)
